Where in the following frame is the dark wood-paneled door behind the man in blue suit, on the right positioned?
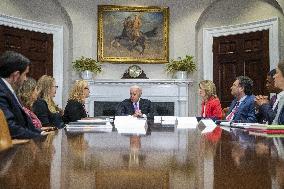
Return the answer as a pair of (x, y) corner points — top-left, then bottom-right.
(213, 30), (269, 108)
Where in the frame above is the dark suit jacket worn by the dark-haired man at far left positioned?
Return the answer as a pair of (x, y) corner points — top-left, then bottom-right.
(0, 79), (41, 139)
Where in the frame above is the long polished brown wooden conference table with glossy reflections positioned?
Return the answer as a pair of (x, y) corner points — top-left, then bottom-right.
(0, 124), (284, 189)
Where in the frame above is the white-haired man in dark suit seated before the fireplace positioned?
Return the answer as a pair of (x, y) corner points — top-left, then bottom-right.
(116, 85), (153, 119)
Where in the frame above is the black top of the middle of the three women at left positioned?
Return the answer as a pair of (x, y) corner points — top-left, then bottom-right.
(32, 98), (65, 129)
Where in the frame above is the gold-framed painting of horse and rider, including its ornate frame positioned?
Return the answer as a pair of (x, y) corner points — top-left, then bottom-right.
(98, 5), (169, 63)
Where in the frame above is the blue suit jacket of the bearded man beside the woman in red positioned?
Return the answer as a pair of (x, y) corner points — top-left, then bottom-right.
(228, 95), (257, 123)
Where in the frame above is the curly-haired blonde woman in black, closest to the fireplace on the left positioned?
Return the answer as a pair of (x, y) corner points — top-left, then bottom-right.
(63, 80), (90, 123)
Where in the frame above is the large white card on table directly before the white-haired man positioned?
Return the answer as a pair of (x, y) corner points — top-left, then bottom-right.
(114, 116), (148, 135)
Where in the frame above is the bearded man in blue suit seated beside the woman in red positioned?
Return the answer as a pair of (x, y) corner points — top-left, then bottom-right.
(226, 76), (256, 123)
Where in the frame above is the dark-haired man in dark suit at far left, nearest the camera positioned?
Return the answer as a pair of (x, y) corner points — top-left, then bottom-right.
(0, 51), (41, 139)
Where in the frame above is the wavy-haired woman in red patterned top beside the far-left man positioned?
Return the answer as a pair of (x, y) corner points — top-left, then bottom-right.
(17, 78), (42, 128)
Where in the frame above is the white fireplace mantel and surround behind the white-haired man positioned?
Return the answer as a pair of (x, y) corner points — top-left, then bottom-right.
(86, 79), (193, 116)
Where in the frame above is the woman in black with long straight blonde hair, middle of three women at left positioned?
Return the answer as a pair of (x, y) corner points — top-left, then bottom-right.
(33, 75), (65, 128)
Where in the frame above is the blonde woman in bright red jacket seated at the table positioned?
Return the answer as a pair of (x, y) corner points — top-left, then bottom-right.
(199, 80), (222, 120)
